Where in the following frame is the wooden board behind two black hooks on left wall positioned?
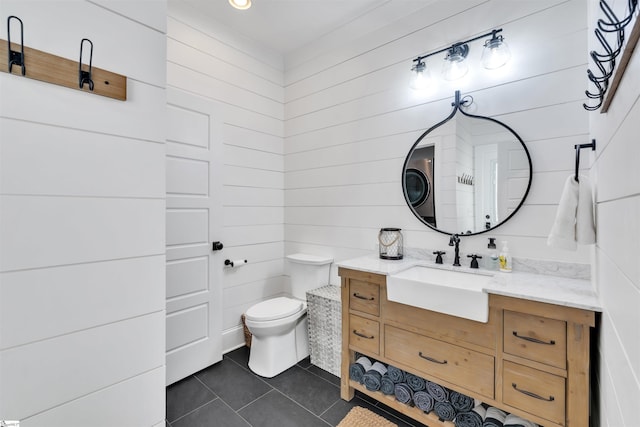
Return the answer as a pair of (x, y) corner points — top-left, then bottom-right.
(0, 39), (127, 101)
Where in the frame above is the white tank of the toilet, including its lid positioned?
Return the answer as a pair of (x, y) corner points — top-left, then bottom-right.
(286, 254), (333, 300)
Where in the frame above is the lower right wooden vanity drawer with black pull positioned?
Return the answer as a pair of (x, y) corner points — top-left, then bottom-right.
(502, 360), (565, 425)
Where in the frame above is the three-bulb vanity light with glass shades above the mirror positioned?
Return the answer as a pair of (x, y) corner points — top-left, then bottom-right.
(410, 28), (511, 89)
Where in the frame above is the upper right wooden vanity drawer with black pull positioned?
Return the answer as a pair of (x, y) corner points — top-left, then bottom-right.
(504, 310), (567, 369)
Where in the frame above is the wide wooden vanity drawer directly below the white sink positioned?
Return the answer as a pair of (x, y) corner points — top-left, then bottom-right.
(384, 325), (494, 399)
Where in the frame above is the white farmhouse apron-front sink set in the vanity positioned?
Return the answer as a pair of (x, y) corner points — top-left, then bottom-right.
(387, 266), (493, 323)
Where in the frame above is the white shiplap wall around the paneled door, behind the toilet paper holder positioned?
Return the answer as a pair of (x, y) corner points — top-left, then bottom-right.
(167, 1), (285, 351)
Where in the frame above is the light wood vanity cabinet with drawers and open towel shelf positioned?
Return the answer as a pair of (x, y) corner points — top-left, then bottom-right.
(339, 267), (595, 427)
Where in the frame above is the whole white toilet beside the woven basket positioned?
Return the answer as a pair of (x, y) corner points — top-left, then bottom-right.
(245, 254), (333, 378)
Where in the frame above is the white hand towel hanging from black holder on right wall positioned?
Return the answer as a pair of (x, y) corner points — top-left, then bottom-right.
(547, 175), (596, 251)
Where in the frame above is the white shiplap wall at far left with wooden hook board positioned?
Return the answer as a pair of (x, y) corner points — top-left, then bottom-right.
(0, 0), (166, 427)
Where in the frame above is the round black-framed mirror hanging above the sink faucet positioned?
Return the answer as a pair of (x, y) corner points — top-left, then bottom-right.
(401, 91), (533, 235)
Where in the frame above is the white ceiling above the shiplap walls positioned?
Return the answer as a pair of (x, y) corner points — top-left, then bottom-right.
(178, 0), (392, 56)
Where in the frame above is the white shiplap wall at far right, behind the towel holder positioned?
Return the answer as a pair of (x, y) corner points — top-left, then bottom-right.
(589, 0), (640, 427)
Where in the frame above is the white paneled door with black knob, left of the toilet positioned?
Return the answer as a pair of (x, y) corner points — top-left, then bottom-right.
(166, 88), (224, 385)
